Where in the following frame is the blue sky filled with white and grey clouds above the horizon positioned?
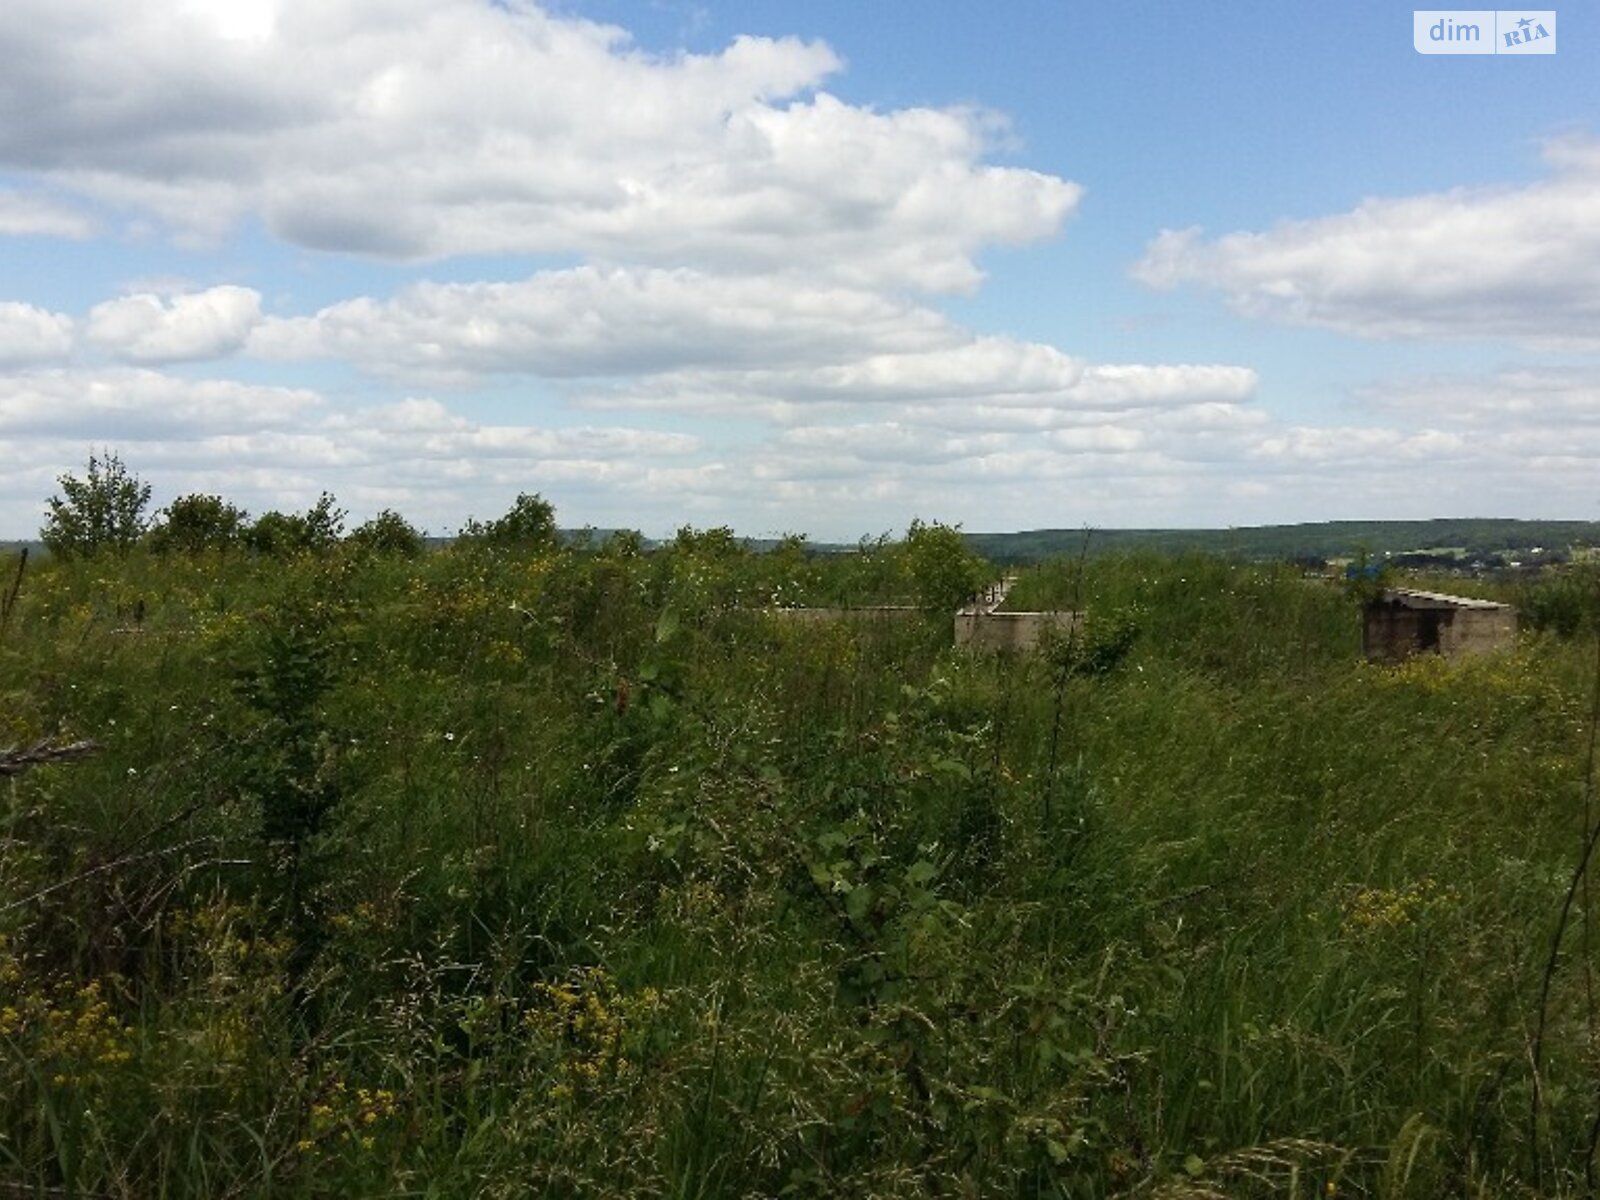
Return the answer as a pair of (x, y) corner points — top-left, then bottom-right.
(0, 0), (1600, 539)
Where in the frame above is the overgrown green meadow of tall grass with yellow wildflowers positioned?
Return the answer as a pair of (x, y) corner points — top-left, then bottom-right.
(0, 534), (1600, 1200)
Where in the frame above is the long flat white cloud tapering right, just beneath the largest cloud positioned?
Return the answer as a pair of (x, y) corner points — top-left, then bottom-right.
(248, 266), (1256, 418)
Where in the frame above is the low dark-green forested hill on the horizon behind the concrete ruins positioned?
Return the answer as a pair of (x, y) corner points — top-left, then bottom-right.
(966, 518), (1600, 563)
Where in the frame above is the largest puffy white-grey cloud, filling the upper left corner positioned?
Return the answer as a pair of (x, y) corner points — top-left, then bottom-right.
(0, 0), (1080, 290)
